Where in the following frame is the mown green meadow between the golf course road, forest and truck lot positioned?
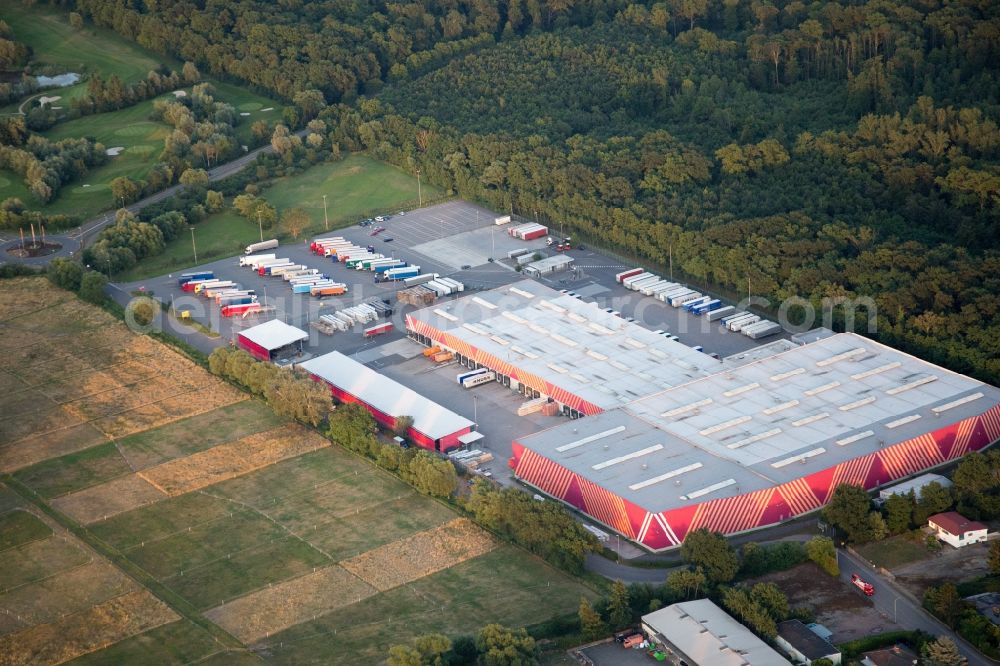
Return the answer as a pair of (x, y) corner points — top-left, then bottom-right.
(115, 155), (441, 282)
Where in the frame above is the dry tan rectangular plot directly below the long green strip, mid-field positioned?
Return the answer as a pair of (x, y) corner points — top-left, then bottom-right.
(139, 425), (330, 496)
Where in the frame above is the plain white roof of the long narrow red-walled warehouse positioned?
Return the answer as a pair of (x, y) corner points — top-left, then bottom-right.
(299, 352), (475, 439)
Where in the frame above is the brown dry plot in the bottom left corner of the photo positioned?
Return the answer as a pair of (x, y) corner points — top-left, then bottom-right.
(0, 590), (178, 664)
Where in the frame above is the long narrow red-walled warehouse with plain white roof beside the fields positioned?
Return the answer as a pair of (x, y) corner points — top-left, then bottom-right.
(298, 352), (476, 452)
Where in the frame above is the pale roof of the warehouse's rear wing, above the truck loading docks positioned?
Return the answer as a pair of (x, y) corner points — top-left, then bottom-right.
(411, 280), (722, 409)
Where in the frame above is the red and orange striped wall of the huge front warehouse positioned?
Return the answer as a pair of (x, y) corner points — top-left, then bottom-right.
(510, 405), (1000, 550)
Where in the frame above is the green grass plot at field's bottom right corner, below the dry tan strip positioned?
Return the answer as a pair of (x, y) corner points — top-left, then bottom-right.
(265, 546), (594, 664)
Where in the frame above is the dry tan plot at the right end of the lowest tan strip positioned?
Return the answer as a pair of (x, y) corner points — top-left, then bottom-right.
(341, 518), (497, 592)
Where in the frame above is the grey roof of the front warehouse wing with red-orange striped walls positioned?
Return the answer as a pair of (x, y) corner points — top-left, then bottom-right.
(518, 333), (1000, 511)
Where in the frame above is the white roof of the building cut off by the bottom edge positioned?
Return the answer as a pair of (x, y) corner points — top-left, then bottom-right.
(642, 599), (789, 666)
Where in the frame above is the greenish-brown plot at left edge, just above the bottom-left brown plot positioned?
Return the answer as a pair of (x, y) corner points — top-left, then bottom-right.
(0, 560), (136, 636)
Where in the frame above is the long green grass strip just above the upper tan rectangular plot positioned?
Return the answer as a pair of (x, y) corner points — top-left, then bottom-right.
(15, 400), (282, 499)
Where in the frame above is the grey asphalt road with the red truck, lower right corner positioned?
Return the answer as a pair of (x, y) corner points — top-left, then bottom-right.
(837, 549), (996, 666)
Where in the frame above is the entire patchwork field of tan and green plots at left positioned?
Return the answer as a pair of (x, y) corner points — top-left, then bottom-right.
(0, 278), (594, 664)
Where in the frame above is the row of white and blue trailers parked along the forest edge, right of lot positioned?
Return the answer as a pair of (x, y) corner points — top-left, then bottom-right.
(615, 268), (781, 340)
